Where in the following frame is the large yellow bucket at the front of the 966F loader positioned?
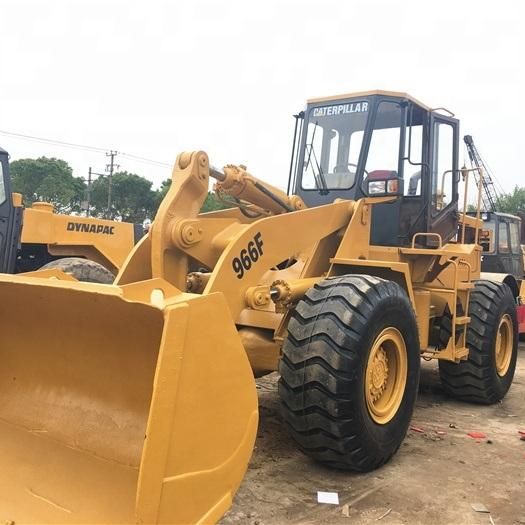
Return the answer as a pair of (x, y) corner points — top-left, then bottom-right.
(0, 275), (257, 525)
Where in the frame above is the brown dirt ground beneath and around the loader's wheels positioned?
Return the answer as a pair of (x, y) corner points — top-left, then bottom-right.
(221, 343), (525, 525)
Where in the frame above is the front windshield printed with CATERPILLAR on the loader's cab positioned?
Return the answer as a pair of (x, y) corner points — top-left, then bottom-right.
(302, 100), (369, 191)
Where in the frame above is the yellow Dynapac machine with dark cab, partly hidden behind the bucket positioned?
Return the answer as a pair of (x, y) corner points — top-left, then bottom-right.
(0, 148), (143, 284)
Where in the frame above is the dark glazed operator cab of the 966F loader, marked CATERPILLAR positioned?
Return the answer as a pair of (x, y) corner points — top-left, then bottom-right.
(289, 91), (459, 246)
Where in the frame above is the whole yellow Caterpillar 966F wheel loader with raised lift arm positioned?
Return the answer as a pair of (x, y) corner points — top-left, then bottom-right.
(0, 91), (517, 524)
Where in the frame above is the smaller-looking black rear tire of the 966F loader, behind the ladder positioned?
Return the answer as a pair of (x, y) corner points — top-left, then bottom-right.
(439, 281), (518, 405)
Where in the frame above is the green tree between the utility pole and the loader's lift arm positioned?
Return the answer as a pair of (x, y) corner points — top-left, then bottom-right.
(91, 171), (157, 223)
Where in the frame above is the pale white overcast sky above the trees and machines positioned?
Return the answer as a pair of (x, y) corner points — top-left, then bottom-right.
(0, 0), (525, 195)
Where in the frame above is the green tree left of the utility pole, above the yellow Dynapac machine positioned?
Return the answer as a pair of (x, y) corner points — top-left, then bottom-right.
(10, 157), (86, 213)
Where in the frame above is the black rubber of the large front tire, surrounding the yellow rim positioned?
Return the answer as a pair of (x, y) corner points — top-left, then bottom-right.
(279, 275), (420, 472)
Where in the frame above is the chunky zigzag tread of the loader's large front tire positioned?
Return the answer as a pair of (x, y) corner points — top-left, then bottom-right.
(279, 275), (419, 471)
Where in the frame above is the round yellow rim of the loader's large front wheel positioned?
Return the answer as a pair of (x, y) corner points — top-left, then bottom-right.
(365, 327), (408, 425)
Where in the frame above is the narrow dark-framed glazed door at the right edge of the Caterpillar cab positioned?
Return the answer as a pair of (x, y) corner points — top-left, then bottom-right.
(426, 113), (459, 243)
